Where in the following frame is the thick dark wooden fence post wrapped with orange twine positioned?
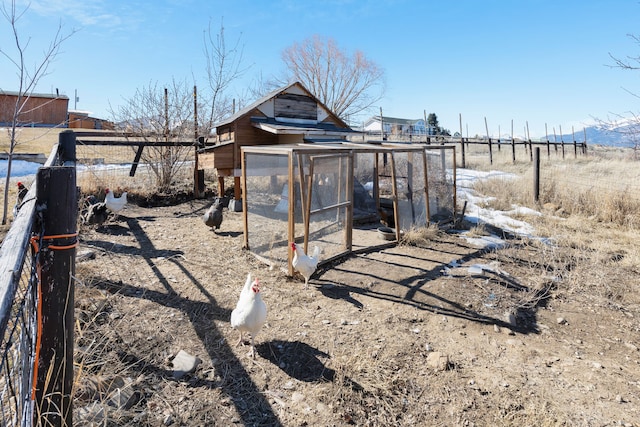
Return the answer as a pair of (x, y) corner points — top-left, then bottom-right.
(34, 131), (78, 427)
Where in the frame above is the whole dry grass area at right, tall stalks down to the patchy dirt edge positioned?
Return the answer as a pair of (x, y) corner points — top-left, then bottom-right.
(462, 143), (640, 304)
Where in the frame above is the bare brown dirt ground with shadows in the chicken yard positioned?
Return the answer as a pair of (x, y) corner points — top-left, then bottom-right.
(74, 200), (640, 426)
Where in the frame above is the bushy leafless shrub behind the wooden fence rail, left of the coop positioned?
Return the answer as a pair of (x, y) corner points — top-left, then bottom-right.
(110, 80), (194, 192)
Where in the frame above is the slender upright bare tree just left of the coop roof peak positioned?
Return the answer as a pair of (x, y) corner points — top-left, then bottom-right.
(201, 21), (247, 135)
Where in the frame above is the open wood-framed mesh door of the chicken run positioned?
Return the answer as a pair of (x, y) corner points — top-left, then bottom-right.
(302, 153), (353, 259)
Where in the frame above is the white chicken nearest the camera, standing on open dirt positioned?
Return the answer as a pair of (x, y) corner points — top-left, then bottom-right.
(231, 273), (267, 359)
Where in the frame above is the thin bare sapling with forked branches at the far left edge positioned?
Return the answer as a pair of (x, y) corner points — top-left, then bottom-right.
(0, 0), (75, 225)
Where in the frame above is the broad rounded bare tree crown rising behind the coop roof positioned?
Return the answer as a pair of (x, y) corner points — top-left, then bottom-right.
(282, 35), (385, 120)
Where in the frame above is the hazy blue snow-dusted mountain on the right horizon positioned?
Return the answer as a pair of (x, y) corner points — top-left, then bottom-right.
(542, 121), (640, 147)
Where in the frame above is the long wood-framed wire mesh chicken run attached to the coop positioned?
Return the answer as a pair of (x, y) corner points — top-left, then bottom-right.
(241, 141), (456, 276)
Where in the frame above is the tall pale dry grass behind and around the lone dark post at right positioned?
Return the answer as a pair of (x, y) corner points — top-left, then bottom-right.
(464, 144), (640, 230)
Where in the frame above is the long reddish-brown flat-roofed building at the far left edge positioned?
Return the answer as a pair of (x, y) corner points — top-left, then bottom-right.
(0, 91), (69, 127)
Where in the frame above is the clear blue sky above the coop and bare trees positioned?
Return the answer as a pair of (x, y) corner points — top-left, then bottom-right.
(0, 0), (640, 137)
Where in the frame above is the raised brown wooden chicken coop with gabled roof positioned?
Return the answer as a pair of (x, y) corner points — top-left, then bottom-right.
(198, 82), (357, 207)
